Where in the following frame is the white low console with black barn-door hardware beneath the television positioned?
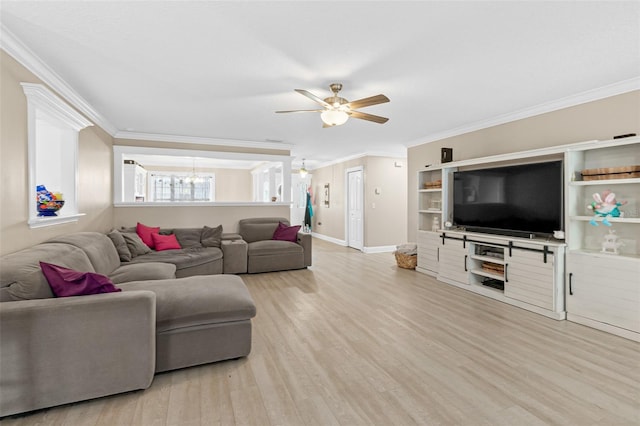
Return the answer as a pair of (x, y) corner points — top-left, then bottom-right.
(417, 230), (566, 320)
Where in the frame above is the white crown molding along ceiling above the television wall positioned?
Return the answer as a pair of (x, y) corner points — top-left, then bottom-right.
(406, 77), (640, 148)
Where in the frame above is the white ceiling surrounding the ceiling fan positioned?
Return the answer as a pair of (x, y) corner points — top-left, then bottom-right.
(0, 0), (640, 166)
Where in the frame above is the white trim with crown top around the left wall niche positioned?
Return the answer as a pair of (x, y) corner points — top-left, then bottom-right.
(20, 83), (93, 228)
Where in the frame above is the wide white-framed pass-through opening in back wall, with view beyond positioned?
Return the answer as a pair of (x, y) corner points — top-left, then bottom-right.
(113, 145), (291, 206)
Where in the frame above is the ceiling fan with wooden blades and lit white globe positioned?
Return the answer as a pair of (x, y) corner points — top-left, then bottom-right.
(276, 83), (389, 127)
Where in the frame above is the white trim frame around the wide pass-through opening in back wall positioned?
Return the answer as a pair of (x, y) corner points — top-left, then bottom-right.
(113, 145), (291, 207)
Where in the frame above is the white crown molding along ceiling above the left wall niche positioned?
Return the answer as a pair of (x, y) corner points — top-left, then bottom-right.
(0, 23), (117, 136)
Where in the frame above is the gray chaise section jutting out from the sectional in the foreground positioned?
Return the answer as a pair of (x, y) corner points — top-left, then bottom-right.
(119, 275), (256, 372)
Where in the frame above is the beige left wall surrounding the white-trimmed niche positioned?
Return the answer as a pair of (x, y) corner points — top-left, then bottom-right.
(0, 50), (113, 254)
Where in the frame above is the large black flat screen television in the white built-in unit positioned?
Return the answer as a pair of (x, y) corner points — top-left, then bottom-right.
(453, 161), (563, 237)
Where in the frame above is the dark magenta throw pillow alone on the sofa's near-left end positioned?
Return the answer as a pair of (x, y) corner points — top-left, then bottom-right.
(40, 262), (122, 297)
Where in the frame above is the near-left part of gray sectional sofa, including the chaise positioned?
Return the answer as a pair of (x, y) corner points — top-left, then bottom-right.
(0, 232), (256, 417)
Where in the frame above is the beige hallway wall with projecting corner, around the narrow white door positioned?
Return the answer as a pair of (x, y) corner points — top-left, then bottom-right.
(312, 156), (407, 248)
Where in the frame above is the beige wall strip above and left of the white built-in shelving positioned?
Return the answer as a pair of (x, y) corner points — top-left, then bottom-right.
(407, 91), (640, 241)
